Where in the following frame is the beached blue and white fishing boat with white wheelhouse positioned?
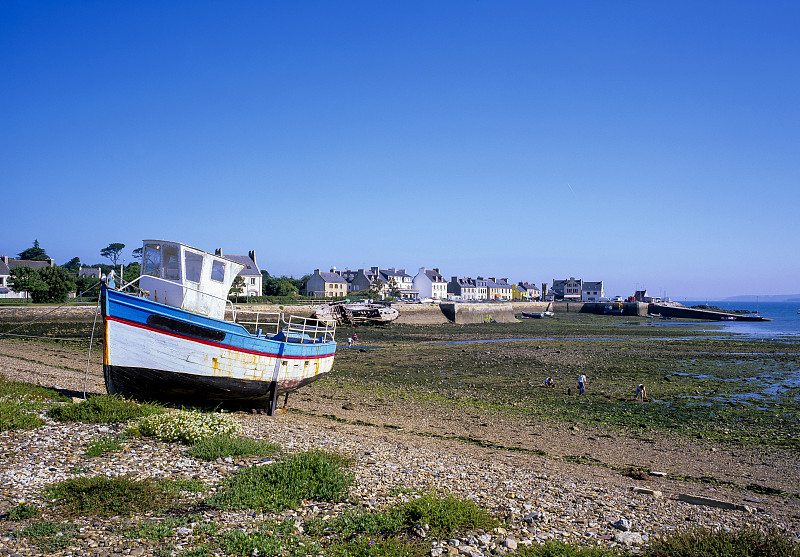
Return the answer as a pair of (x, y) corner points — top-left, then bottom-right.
(101, 240), (336, 415)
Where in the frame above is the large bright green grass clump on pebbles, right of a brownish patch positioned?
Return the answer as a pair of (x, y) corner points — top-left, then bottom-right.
(207, 451), (353, 512)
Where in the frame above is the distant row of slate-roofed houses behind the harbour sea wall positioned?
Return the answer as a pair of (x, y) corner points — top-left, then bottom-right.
(303, 267), (605, 302)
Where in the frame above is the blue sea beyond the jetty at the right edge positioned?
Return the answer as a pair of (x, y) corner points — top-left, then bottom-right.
(674, 299), (800, 341)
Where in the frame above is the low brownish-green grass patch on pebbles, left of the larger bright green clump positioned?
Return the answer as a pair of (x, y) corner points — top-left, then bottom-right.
(45, 476), (202, 516)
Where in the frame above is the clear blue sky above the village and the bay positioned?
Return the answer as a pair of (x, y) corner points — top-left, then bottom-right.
(0, 0), (800, 299)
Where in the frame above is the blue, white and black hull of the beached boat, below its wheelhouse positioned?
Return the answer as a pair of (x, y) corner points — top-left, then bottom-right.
(101, 239), (336, 414)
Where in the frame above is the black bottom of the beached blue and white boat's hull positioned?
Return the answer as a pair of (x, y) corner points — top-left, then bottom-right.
(103, 365), (317, 408)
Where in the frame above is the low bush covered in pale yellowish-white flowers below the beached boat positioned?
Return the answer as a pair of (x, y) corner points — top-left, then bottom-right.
(128, 410), (241, 445)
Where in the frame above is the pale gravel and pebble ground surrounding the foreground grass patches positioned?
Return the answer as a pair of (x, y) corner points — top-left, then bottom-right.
(0, 341), (800, 557)
